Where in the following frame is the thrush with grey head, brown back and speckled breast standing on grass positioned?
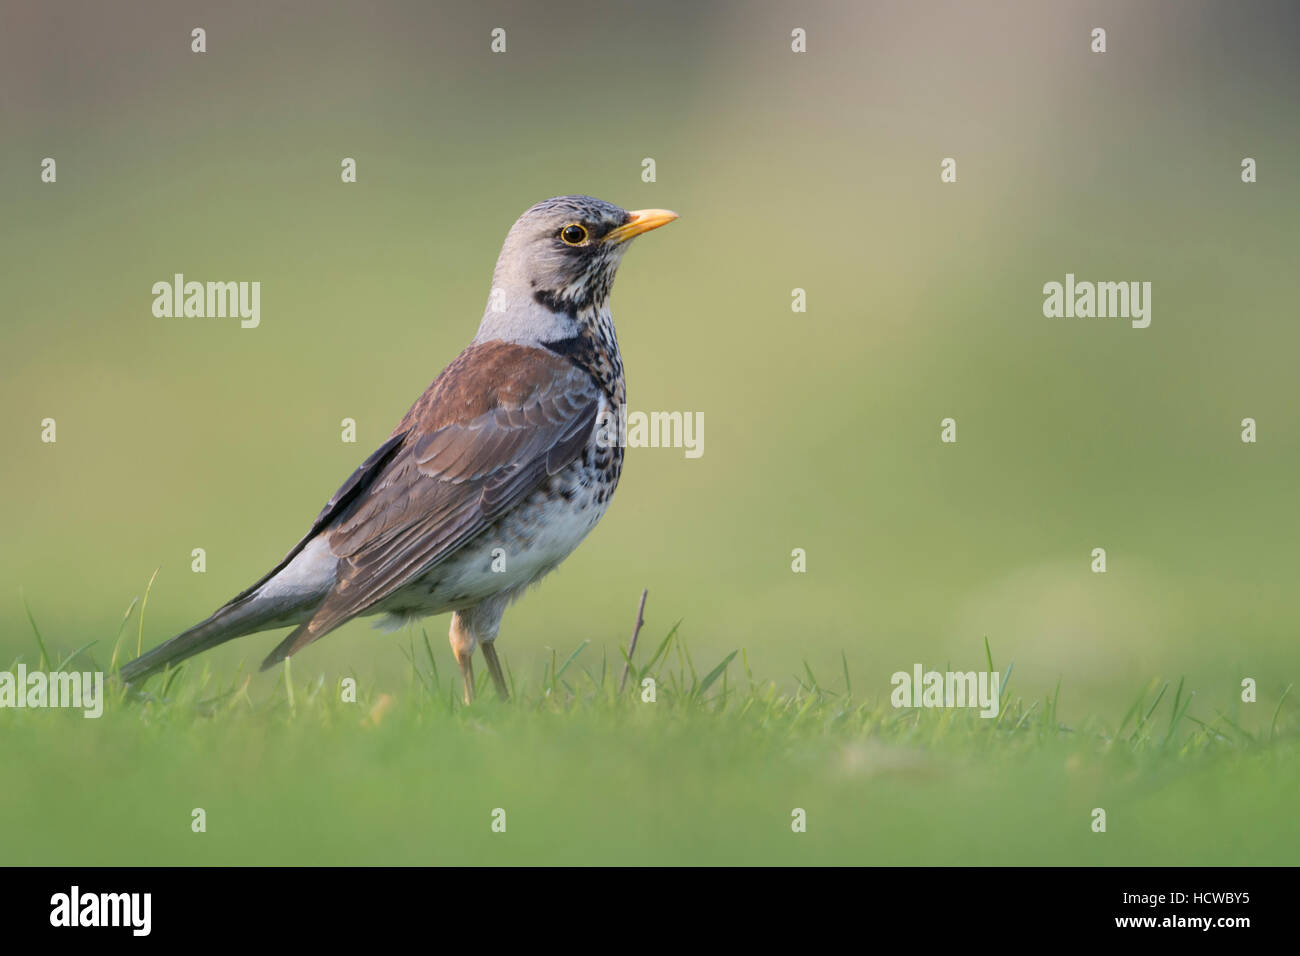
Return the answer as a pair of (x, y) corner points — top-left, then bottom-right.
(120, 195), (677, 704)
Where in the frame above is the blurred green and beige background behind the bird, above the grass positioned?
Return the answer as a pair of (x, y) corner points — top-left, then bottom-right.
(0, 0), (1300, 868)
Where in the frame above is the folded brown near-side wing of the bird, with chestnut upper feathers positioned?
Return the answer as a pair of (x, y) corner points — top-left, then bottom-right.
(263, 342), (601, 670)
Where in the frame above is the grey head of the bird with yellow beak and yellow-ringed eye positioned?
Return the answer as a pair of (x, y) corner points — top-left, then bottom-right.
(476, 196), (677, 343)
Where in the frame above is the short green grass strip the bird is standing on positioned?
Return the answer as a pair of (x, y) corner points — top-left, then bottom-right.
(0, 590), (1300, 865)
